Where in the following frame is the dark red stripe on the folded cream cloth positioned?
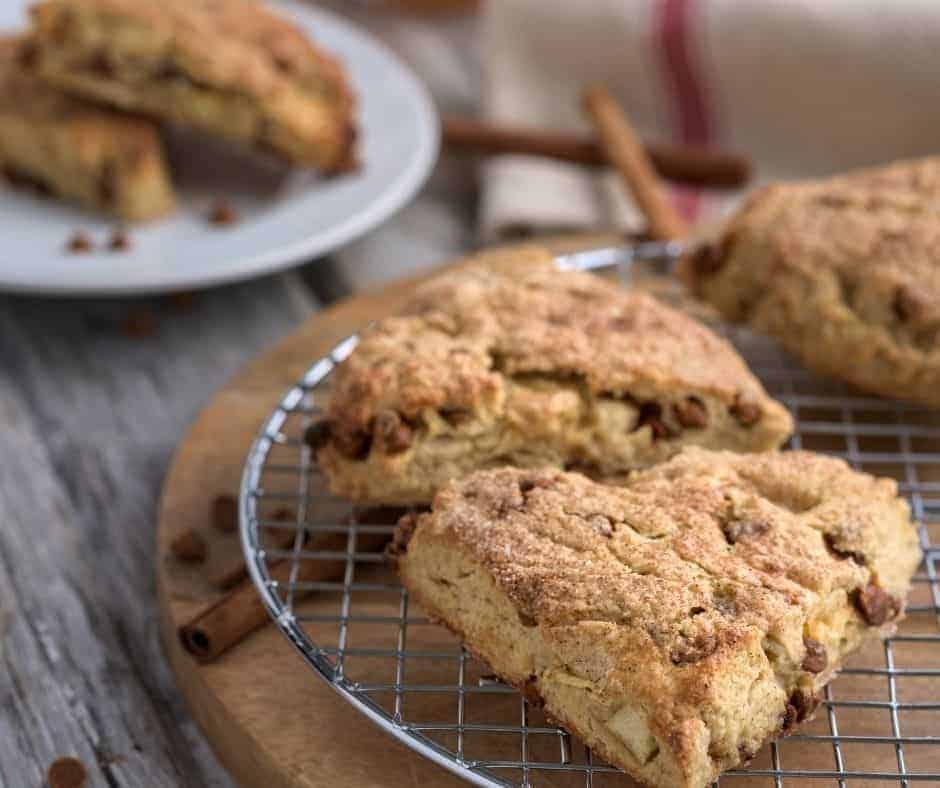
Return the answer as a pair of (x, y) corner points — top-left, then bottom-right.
(654, 0), (712, 219)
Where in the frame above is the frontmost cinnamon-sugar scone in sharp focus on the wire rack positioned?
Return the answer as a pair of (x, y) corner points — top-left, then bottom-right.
(391, 448), (921, 788)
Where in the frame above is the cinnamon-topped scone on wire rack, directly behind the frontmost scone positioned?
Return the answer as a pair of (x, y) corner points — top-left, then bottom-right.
(308, 246), (792, 504)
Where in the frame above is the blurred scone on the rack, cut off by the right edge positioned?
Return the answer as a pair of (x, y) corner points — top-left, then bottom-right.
(680, 158), (940, 407)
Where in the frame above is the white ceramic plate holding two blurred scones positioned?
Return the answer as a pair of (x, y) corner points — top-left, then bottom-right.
(0, 0), (439, 295)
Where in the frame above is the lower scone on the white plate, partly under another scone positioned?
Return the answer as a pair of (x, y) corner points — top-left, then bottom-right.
(0, 36), (174, 220)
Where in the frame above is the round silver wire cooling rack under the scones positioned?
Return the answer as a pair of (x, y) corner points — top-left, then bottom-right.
(240, 254), (940, 788)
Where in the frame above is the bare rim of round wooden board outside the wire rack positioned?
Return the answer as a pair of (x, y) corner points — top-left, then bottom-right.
(156, 236), (604, 788)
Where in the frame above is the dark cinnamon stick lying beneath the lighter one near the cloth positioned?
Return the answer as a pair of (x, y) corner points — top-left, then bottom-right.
(442, 115), (751, 189)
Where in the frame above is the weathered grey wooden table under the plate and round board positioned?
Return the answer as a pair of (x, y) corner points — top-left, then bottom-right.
(0, 2), (479, 788)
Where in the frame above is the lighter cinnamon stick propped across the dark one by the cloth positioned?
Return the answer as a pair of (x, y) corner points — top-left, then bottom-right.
(584, 87), (688, 241)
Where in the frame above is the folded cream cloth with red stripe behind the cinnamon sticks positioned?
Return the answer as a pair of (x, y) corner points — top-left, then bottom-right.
(481, 0), (940, 238)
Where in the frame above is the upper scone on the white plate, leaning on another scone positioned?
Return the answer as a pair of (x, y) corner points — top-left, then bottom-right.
(33, 0), (355, 173)
